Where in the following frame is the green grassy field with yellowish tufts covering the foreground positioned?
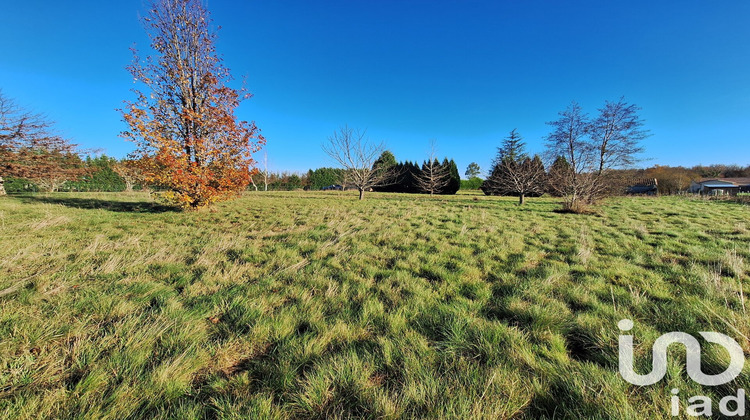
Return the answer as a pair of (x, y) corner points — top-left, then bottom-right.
(0, 192), (750, 419)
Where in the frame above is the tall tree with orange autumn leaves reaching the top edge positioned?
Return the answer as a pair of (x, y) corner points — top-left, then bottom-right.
(122, 0), (265, 209)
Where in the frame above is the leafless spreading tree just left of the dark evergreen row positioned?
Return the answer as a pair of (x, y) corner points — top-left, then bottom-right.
(323, 125), (394, 200)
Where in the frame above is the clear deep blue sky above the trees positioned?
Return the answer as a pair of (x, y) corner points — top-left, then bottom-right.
(0, 0), (750, 174)
